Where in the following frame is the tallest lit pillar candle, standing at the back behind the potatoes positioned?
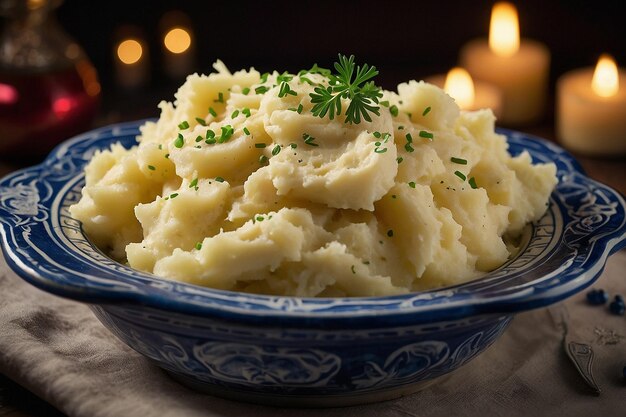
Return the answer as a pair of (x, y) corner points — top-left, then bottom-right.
(460, 3), (550, 125)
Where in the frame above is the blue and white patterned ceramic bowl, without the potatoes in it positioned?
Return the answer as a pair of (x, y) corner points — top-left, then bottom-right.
(0, 122), (626, 406)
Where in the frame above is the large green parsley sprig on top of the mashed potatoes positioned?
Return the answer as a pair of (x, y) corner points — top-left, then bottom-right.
(309, 54), (383, 124)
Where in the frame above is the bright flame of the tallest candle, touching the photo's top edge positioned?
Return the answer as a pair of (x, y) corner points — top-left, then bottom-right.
(489, 2), (520, 57)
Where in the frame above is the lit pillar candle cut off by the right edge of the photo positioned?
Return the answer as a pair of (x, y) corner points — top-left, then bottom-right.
(557, 55), (626, 155)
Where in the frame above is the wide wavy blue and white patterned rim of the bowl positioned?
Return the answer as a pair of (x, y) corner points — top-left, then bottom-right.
(0, 119), (626, 326)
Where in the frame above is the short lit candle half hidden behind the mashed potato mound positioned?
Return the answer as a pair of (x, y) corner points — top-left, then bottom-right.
(425, 67), (502, 117)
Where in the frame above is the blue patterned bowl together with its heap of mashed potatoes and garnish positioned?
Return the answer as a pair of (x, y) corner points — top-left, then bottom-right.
(0, 57), (626, 406)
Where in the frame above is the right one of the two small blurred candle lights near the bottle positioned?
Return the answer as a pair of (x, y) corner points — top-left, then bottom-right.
(160, 11), (196, 79)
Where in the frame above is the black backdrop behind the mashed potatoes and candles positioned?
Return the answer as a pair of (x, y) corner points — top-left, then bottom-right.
(52, 0), (626, 118)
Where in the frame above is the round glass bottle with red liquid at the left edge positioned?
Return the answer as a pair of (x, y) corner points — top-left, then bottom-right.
(0, 0), (100, 163)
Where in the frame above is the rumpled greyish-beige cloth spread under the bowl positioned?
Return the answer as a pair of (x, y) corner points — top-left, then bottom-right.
(0, 251), (626, 417)
